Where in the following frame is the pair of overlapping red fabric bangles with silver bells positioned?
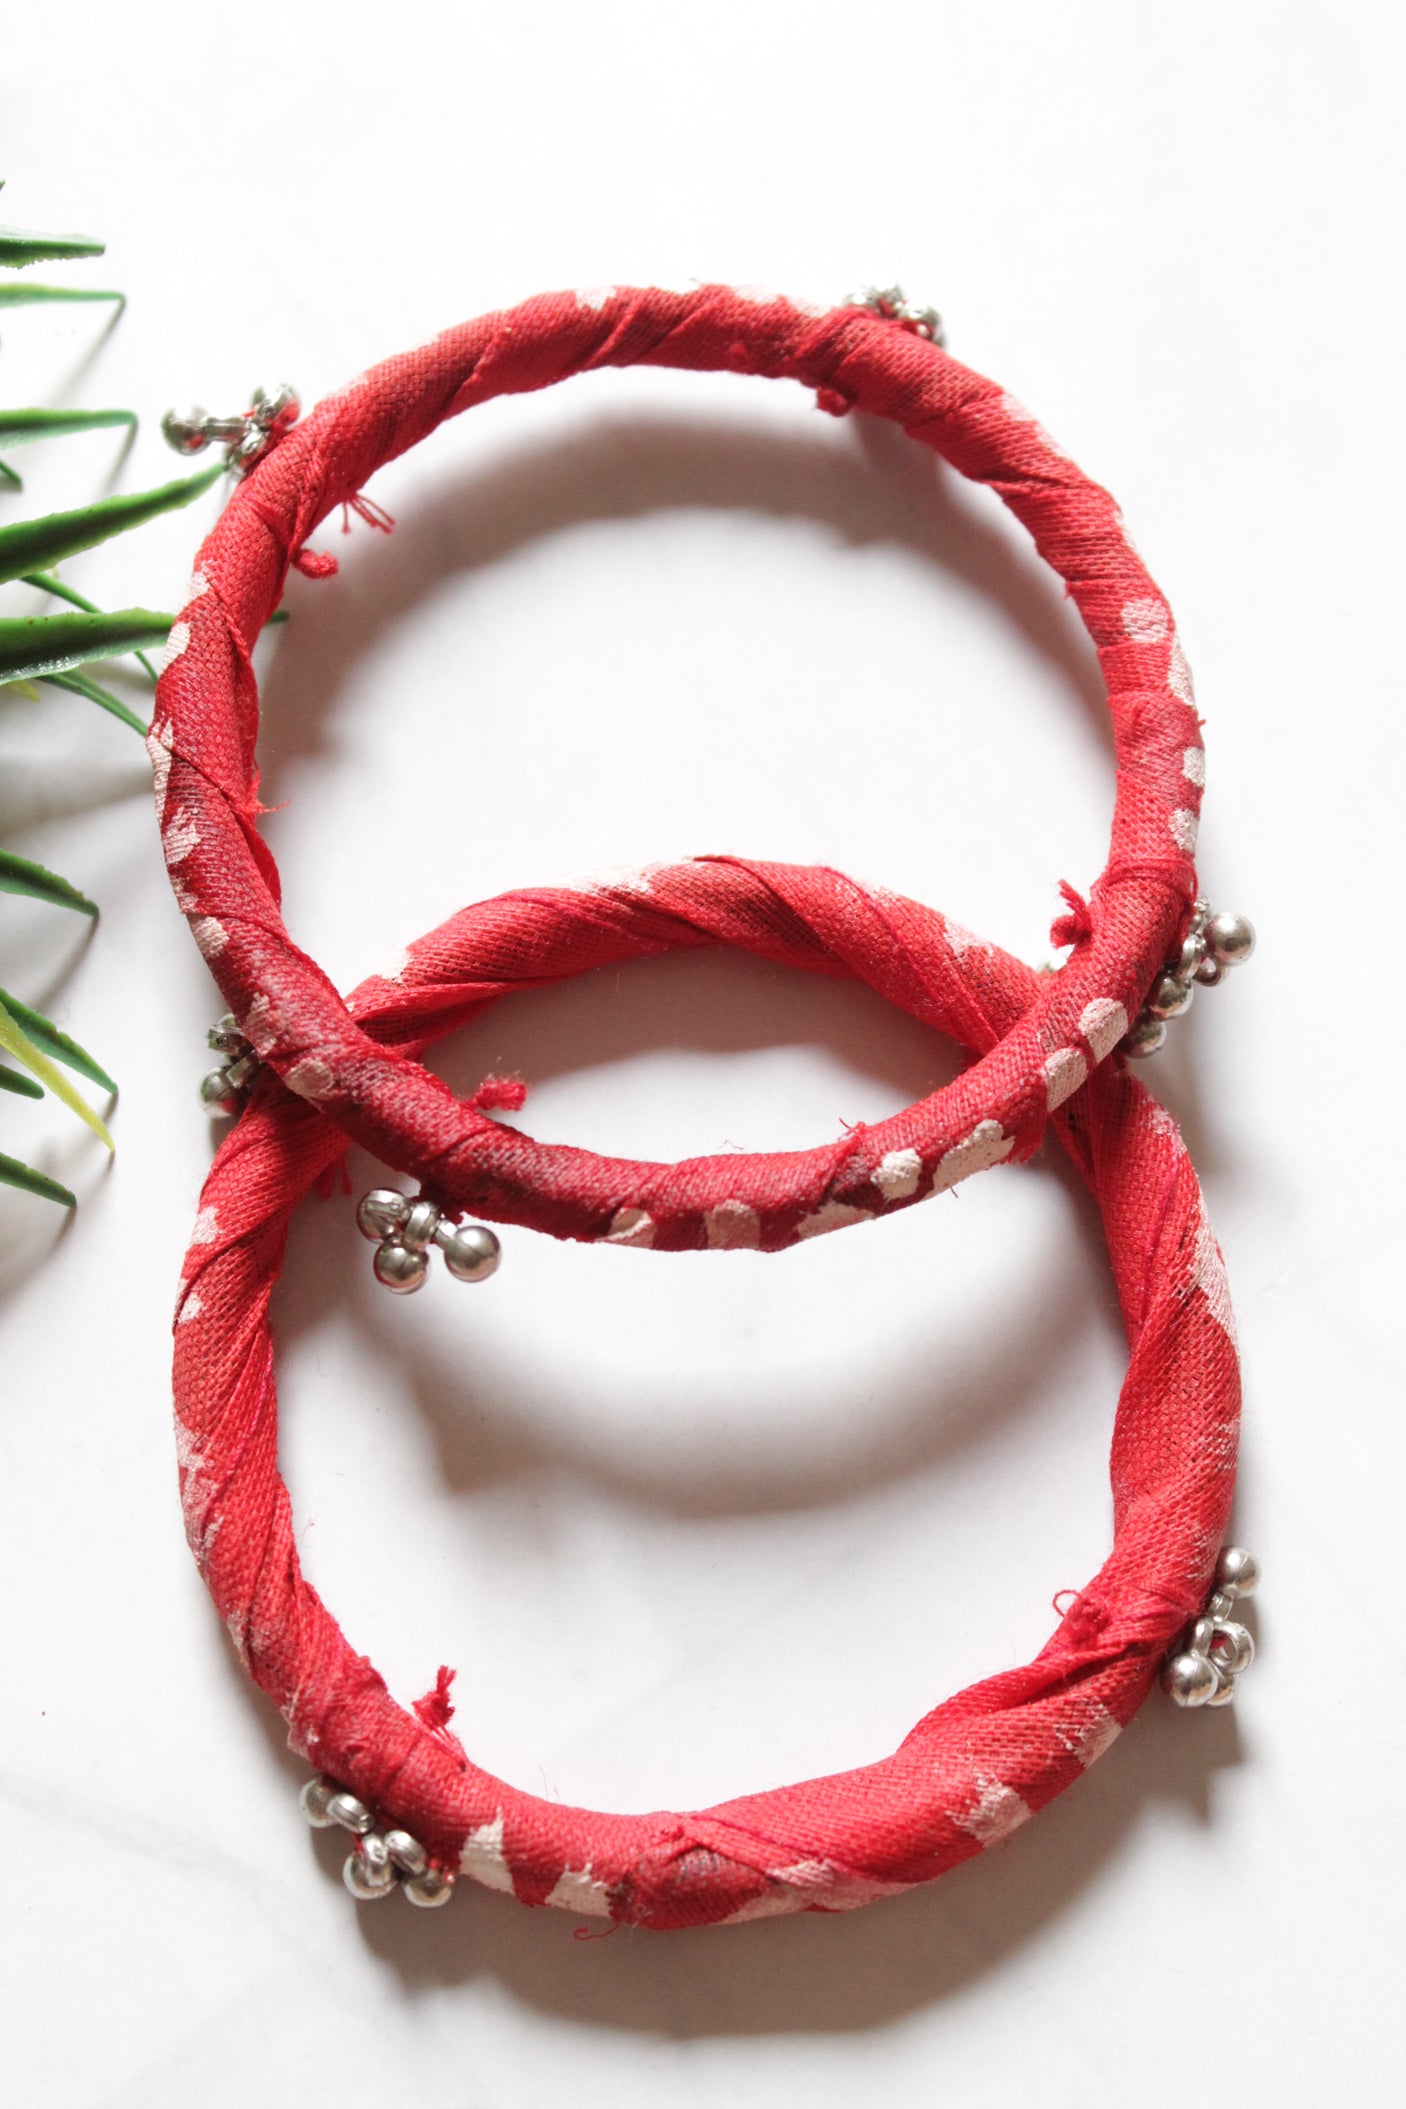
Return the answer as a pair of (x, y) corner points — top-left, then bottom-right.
(159, 287), (1256, 1928)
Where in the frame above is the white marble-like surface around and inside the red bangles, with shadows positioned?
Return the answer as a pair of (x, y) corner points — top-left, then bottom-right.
(0, 0), (1406, 2109)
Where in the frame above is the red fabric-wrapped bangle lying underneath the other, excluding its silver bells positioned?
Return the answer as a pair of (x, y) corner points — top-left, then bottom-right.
(175, 860), (1239, 1928)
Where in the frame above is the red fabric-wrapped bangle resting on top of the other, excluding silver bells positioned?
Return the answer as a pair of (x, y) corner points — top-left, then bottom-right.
(150, 287), (1204, 1251)
